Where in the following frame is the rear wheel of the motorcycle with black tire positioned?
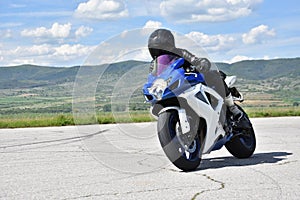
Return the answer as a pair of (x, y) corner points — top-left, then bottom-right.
(225, 105), (256, 158)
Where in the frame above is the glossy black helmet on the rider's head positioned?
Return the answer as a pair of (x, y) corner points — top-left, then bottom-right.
(148, 29), (175, 58)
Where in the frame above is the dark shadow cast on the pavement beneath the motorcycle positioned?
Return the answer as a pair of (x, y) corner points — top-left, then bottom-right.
(198, 152), (292, 170)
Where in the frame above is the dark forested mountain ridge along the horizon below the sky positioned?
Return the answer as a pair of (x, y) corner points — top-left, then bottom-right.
(0, 58), (300, 89)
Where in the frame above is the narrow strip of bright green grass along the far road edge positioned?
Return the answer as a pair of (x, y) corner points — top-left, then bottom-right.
(0, 107), (300, 128)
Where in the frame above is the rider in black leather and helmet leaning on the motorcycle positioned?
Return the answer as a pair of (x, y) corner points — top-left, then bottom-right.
(148, 29), (243, 121)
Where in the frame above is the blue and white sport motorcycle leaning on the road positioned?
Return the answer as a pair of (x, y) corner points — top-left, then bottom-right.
(143, 55), (256, 171)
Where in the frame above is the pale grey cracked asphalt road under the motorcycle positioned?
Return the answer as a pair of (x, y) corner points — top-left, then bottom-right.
(0, 117), (300, 200)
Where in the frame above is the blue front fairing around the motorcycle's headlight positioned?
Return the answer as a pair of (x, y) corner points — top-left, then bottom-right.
(143, 58), (205, 104)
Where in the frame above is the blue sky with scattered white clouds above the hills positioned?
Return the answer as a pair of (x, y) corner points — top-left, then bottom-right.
(0, 0), (300, 66)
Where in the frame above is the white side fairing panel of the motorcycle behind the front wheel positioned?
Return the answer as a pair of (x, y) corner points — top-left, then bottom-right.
(179, 84), (225, 154)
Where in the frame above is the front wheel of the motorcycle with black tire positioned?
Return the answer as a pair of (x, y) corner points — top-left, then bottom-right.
(157, 110), (201, 171)
